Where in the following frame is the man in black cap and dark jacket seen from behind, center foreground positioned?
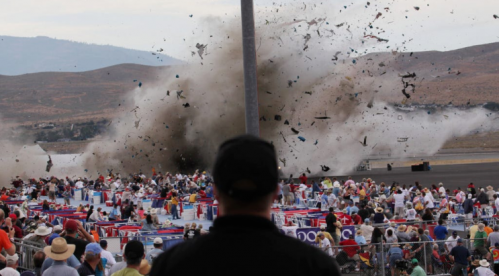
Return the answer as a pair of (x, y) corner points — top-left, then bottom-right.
(150, 135), (340, 276)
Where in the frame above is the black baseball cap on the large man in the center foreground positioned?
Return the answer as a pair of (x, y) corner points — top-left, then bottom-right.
(213, 135), (279, 202)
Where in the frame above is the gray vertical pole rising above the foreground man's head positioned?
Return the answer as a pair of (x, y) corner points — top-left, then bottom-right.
(241, 0), (260, 137)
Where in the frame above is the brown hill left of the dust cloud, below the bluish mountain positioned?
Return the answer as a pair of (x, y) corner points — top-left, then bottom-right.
(0, 64), (167, 125)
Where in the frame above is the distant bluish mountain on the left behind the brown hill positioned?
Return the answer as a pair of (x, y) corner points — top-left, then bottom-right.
(0, 36), (180, 76)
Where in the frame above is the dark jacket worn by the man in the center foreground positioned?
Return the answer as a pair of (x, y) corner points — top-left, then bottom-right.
(150, 215), (341, 276)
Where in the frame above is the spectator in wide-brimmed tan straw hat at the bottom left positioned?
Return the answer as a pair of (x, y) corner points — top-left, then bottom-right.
(42, 238), (79, 276)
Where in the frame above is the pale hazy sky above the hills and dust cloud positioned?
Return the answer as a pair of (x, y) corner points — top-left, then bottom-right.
(0, 0), (499, 58)
